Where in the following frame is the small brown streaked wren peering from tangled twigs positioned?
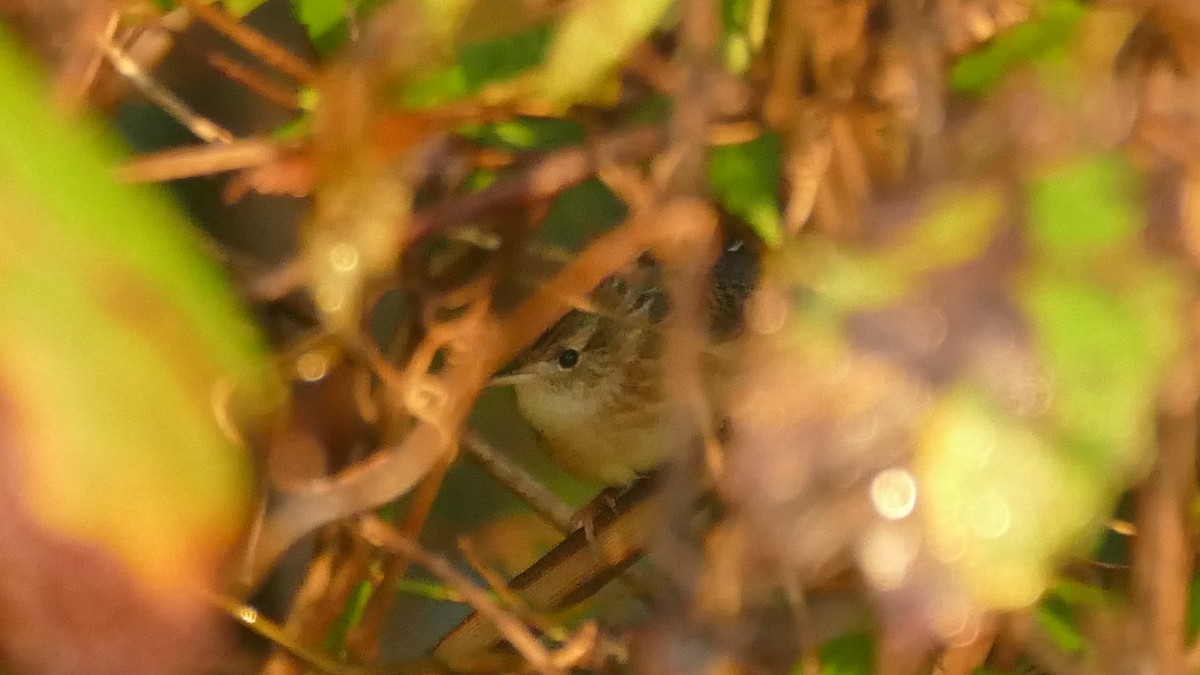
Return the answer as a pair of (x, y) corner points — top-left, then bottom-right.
(496, 241), (758, 485)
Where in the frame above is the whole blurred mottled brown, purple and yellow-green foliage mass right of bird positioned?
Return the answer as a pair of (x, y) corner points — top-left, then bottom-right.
(726, 154), (1186, 639)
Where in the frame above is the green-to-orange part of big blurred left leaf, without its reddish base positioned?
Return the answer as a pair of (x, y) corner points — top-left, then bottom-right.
(0, 35), (277, 590)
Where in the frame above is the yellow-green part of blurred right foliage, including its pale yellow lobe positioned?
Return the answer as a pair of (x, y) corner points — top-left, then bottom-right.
(919, 156), (1183, 607)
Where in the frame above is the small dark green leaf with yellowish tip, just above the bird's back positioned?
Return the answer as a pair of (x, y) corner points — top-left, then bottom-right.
(708, 133), (784, 247)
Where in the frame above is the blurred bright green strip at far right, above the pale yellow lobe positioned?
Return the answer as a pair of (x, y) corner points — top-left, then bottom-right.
(1020, 156), (1184, 475)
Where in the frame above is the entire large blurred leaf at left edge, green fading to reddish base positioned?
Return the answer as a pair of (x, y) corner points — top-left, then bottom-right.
(0, 28), (277, 673)
